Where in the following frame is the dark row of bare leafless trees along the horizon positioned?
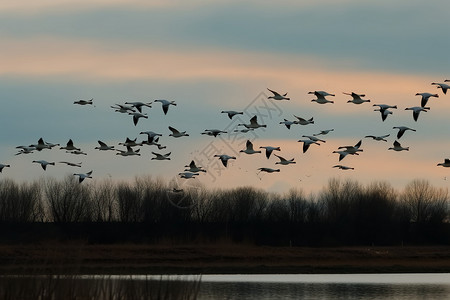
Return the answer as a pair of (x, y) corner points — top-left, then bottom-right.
(0, 176), (450, 246)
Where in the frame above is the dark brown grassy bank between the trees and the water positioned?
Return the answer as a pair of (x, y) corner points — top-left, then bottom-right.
(0, 243), (450, 275)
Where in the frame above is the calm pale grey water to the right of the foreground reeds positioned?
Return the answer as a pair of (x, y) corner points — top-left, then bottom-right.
(194, 273), (450, 300)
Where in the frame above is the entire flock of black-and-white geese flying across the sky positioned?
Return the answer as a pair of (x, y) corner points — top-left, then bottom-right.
(0, 79), (450, 185)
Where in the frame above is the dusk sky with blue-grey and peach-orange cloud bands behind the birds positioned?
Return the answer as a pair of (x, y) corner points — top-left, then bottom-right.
(0, 0), (450, 193)
